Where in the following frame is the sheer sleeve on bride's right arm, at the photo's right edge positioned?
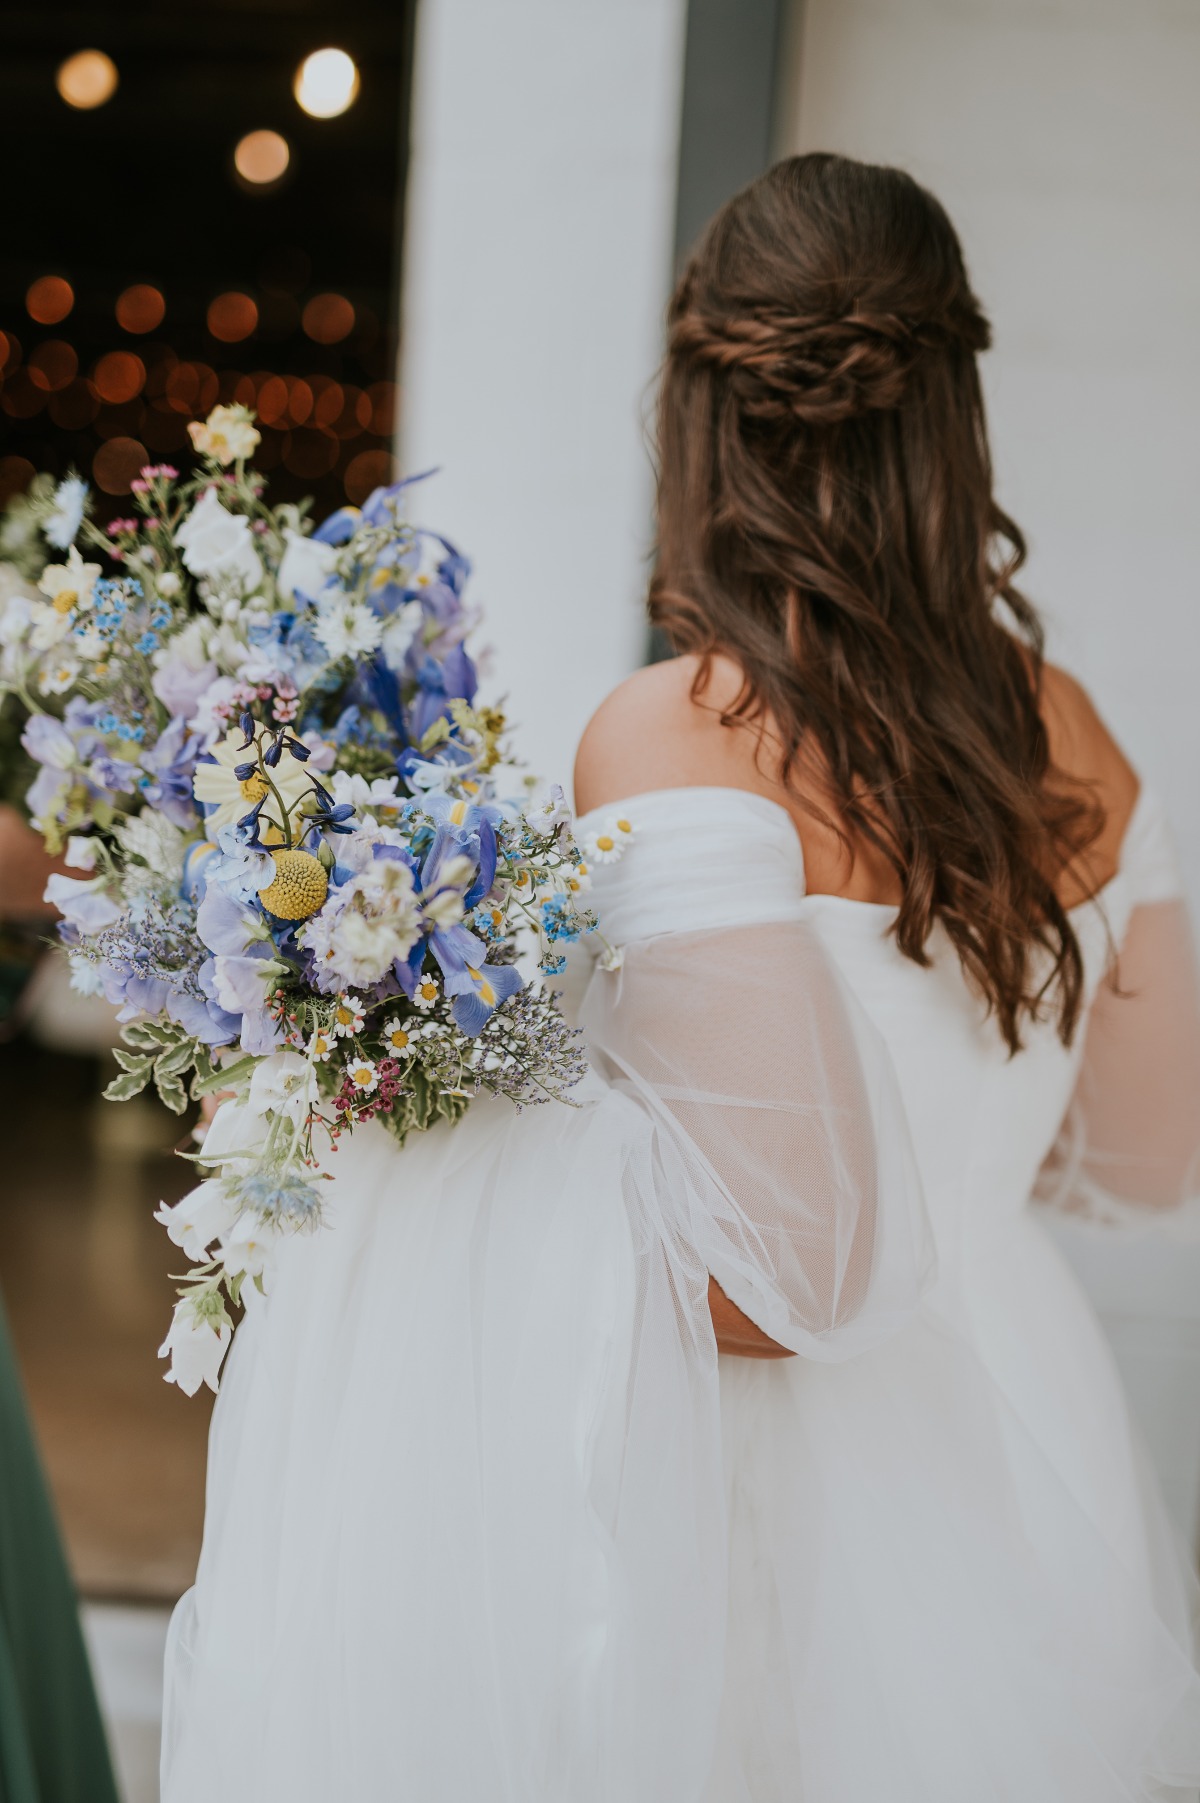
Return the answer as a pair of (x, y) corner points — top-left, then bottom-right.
(1036, 797), (1200, 1237)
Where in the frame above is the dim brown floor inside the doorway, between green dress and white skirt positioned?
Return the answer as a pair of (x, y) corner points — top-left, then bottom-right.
(0, 1039), (211, 1601)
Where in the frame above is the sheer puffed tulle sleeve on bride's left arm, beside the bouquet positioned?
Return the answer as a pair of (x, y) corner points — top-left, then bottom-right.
(584, 920), (933, 1359)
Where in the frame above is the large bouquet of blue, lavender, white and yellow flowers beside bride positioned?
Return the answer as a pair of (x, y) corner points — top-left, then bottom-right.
(0, 407), (607, 1394)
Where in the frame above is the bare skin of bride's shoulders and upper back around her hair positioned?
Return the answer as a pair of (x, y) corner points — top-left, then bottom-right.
(575, 656), (1139, 907)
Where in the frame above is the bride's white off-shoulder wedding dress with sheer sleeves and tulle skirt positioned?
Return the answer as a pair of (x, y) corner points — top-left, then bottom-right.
(164, 788), (1200, 1803)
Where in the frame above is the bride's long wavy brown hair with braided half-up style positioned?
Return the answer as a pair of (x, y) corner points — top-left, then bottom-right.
(650, 155), (1103, 1051)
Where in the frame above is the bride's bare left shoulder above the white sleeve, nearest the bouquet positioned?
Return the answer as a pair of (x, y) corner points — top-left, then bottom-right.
(575, 656), (744, 813)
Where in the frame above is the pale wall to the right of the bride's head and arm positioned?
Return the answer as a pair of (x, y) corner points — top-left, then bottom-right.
(780, 0), (1200, 1531)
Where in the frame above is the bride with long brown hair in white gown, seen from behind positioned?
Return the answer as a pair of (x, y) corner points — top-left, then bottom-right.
(164, 157), (1200, 1803)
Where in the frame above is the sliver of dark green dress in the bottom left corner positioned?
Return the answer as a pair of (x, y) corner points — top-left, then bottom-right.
(0, 1304), (117, 1803)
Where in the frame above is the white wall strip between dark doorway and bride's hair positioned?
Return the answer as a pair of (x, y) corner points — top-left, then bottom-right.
(400, 0), (685, 783)
